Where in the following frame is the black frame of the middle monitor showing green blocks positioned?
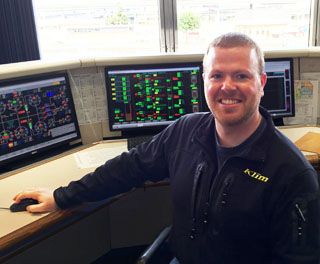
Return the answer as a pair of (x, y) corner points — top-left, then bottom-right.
(104, 61), (207, 134)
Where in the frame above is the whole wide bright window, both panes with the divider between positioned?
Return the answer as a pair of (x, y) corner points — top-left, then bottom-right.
(33, 0), (317, 59)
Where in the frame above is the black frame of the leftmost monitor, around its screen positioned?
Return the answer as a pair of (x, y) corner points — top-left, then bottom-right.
(0, 71), (81, 170)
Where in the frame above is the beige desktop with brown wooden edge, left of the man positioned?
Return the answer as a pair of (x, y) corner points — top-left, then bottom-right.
(0, 140), (127, 257)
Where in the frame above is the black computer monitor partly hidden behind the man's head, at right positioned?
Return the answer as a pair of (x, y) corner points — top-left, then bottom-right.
(261, 58), (295, 125)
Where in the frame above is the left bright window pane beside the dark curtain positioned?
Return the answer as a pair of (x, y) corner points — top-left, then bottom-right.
(33, 0), (160, 59)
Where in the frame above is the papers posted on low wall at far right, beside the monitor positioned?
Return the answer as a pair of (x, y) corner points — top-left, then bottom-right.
(284, 80), (319, 125)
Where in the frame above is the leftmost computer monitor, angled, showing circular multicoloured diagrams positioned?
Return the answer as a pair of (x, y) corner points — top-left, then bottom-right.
(0, 73), (80, 167)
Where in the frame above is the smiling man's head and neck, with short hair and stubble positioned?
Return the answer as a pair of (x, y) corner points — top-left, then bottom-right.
(203, 34), (267, 146)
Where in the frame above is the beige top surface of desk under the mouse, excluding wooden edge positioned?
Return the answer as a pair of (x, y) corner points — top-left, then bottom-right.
(0, 141), (126, 237)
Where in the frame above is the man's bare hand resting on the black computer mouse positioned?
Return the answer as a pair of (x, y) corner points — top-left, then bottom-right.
(13, 188), (58, 213)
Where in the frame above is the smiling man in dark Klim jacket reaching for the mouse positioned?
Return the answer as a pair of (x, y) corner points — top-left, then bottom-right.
(14, 33), (320, 264)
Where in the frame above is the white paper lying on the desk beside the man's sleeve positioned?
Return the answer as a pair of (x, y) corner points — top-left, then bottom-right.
(73, 146), (125, 169)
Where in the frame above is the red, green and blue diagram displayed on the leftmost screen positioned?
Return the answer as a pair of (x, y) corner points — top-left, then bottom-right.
(0, 78), (71, 149)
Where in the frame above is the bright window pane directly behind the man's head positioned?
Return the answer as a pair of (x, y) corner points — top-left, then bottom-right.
(177, 0), (312, 52)
